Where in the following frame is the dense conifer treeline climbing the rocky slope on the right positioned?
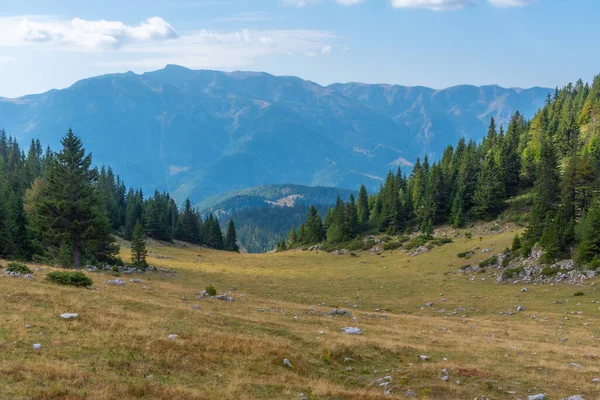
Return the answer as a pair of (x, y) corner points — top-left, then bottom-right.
(288, 76), (600, 263)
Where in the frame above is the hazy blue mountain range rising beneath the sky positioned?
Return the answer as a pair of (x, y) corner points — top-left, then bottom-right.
(0, 65), (549, 203)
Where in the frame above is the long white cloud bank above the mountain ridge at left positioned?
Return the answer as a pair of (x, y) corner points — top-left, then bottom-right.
(0, 16), (335, 70)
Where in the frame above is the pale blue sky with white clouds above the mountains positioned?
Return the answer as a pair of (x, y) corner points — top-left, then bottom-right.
(0, 0), (600, 97)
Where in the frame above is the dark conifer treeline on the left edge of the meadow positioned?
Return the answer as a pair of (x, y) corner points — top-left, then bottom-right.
(0, 130), (238, 266)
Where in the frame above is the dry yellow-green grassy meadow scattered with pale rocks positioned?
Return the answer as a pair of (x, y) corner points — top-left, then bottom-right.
(0, 230), (600, 399)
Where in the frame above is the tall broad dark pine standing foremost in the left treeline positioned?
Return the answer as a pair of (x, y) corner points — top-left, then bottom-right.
(35, 129), (115, 268)
